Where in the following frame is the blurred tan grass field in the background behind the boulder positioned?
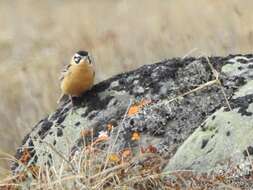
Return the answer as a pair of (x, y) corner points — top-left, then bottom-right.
(0, 0), (253, 174)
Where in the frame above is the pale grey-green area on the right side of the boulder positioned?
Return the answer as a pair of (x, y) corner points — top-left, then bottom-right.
(165, 56), (253, 176)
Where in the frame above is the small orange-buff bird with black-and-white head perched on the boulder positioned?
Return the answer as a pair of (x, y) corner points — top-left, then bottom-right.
(57, 50), (95, 105)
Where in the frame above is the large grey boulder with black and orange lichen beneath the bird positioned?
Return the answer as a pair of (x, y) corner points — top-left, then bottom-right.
(12, 55), (253, 189)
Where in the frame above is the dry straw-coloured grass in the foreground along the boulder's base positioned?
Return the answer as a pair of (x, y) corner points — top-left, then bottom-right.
(0, 134), (249, 190)
